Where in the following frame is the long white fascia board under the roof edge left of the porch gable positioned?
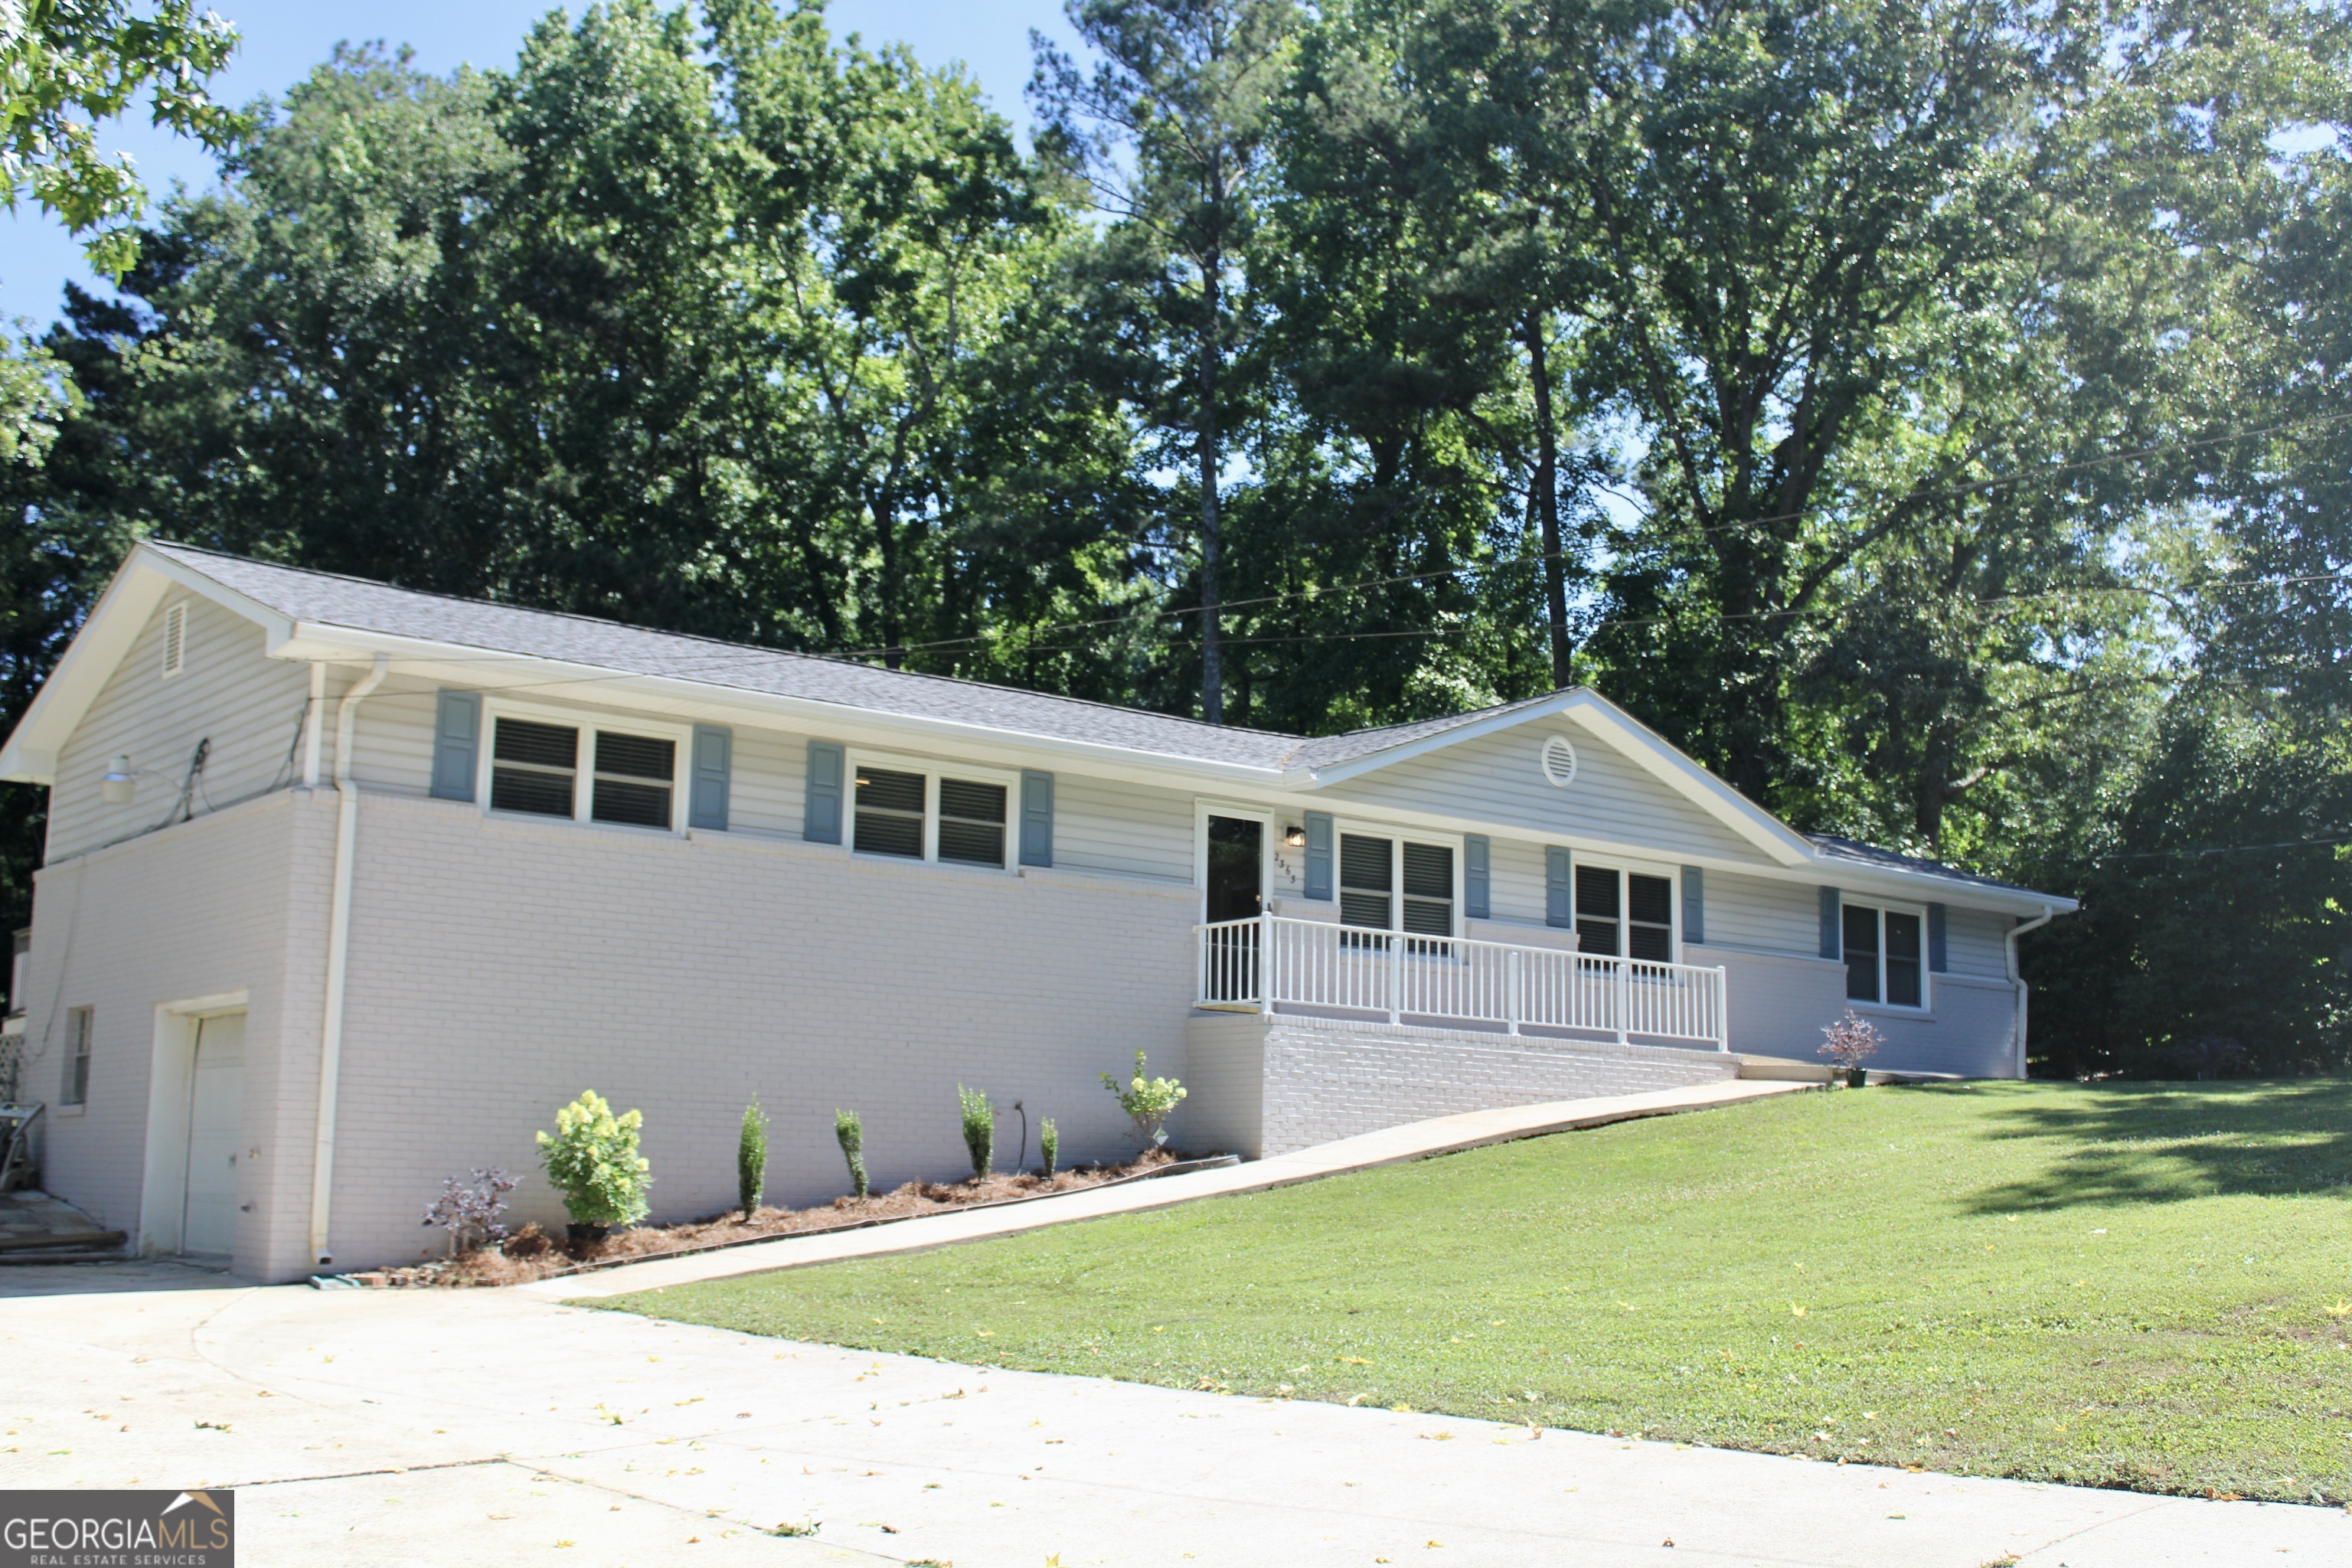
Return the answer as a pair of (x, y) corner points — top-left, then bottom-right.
(270, 623), (1279, 790)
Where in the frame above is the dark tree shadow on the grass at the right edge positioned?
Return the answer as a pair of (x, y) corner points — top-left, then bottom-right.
(1966, 1079), (2352, 1213)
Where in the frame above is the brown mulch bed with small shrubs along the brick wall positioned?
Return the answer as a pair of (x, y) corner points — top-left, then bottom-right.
(344, 1149), (1178, 1291)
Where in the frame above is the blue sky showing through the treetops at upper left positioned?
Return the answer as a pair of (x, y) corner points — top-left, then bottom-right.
(0, 0), (1070, 325)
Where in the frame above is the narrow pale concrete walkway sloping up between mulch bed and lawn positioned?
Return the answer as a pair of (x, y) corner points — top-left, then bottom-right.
(541, 1079), (1816, 1300)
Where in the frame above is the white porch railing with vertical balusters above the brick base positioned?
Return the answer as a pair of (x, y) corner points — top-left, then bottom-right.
(1193, 914), (1731, 1050)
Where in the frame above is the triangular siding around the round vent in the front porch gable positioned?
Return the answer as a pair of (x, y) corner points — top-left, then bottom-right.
(1317, 724), (1764, 861)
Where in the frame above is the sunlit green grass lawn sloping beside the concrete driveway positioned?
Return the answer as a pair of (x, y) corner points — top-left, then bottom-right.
(599, 1079), (2352, 1502)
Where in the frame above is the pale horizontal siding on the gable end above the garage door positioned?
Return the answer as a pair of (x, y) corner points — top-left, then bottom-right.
(47, 599), (311, 863)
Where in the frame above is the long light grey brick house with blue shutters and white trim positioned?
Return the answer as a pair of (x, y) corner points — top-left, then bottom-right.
(0, 543), (2075, 1279)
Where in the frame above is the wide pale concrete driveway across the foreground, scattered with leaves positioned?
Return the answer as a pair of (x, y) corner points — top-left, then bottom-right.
(0, 1265), (2352, 1568)
